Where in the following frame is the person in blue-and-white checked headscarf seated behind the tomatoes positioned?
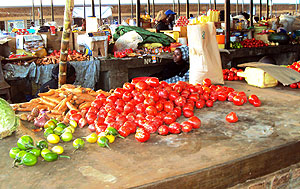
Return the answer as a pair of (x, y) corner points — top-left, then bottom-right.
(150, 45), (189, 83)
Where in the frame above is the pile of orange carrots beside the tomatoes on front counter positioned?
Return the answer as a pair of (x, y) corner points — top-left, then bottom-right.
(12, 84), (110, 122)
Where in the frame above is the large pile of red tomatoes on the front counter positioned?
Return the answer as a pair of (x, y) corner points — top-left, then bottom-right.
(71, 77), (260, 142)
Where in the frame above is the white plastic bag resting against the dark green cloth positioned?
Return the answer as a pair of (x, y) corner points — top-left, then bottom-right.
(115, 31), (143, 51)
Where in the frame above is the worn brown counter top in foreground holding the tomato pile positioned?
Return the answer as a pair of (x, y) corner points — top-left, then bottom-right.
(0, 81), (300, 189)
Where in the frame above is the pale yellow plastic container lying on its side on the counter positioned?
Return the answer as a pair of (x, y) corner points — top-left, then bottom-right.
(237, 67), (278, 88)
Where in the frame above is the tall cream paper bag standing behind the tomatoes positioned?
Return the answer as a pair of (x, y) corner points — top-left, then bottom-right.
(187, 22), (224, 84)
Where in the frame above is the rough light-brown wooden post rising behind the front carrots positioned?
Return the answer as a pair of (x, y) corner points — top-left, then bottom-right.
(58, 0), (74, 88)
